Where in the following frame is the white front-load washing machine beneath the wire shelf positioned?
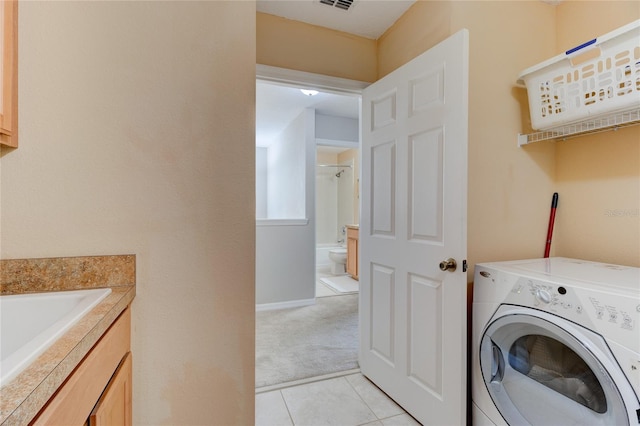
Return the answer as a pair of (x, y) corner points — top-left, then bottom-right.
(472, 257), (640, 426)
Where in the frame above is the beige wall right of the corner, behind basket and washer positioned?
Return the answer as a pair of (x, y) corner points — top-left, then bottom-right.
(555, 1), (640, 266)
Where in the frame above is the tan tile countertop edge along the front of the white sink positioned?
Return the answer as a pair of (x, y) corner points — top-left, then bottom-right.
(0, 257), (136, 426)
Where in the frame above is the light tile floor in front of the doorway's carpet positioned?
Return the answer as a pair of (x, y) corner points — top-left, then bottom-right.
(256, 373), (420, 426)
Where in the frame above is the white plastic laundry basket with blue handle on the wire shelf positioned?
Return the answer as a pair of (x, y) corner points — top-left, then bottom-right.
(518, 20), (640, 130)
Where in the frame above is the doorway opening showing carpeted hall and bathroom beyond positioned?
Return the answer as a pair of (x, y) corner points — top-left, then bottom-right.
(256, 66), (366, 392)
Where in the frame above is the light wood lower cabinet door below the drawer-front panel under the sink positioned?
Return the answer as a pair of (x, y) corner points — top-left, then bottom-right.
(89, 352), (132, 426)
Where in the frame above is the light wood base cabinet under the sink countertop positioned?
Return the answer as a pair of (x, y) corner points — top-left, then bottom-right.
(31, 308), (132, 426)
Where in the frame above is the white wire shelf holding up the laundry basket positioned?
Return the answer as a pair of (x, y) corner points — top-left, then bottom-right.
(518, 107), (640, 146)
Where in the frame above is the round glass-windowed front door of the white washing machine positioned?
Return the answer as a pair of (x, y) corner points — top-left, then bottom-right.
(480, 305), (640, 426)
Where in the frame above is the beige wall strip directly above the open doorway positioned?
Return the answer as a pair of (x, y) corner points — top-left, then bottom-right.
(256, 13), (376, 82)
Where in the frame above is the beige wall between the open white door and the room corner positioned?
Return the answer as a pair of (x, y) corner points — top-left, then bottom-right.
(452, 1), (555, 270)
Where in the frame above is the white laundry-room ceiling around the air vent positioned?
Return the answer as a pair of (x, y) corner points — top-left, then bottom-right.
(256, 0), (415, 39)
